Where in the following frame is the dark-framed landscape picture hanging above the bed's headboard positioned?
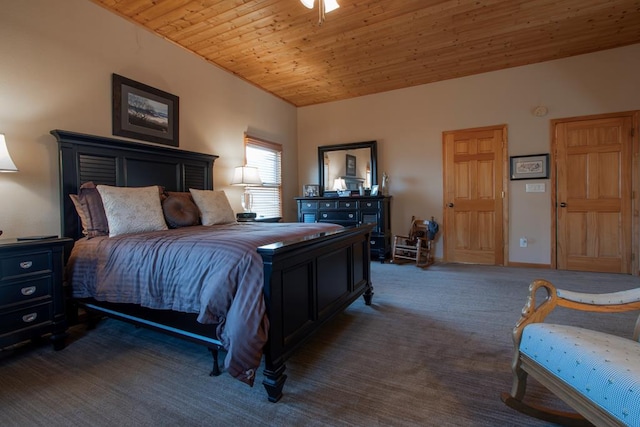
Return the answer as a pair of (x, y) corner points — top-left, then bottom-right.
(111, 73), (180, 147)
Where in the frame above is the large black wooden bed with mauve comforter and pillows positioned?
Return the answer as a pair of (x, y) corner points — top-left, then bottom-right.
(56, 130), (373, 402)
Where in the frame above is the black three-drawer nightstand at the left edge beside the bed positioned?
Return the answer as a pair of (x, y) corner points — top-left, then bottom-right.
(0, 238), (73, 350)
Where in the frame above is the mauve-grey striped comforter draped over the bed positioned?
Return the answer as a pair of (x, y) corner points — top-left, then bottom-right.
(66, 223), (342, 385)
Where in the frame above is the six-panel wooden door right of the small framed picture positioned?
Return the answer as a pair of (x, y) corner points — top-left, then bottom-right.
(554, 114), (634, 273)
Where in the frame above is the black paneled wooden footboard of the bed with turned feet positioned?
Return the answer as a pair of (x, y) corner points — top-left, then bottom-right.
(258, 225), (373, 402)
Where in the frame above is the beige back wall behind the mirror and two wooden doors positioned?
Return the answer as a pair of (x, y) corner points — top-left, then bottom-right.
(298, 44), (640, 264)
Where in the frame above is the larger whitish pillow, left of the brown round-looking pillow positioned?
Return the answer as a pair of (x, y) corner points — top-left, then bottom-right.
(96, 185), (168, 237)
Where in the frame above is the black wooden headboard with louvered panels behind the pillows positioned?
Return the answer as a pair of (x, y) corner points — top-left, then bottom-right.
(51, 129), (218, 240)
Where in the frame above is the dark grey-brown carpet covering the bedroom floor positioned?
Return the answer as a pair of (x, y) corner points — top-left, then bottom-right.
(0, 263), (639, 426)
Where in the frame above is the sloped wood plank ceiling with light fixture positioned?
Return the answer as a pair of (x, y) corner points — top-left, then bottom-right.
(91, 0), (640, 106)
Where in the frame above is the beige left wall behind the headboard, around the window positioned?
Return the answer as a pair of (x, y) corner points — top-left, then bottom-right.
(0, 0), (300, 238)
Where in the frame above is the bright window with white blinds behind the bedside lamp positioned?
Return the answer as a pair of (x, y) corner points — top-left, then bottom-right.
(244, 134), (282, 218)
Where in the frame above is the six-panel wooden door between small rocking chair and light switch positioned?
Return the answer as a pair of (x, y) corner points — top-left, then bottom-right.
(442, 126), (507, 265)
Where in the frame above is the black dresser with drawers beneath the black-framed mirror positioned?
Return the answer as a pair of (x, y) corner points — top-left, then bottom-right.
(296, 196), (391, 262)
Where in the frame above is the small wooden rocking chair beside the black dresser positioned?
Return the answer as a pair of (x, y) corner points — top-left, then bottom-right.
(391, 217), (438, 268)
